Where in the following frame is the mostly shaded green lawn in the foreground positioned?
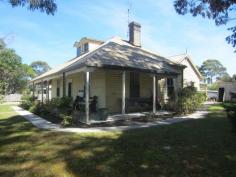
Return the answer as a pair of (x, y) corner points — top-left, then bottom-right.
(0, 105), (236, 177)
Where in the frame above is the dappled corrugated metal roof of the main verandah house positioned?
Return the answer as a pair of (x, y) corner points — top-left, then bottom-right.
(32, 37), (185, 81)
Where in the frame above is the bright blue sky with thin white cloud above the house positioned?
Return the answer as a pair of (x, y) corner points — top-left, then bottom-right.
(0, 0), (236, 75)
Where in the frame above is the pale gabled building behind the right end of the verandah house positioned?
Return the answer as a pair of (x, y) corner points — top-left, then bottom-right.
(169, 54), (203, 91)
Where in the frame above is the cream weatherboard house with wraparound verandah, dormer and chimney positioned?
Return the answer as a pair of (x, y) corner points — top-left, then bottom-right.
(31, 22), (185, 123)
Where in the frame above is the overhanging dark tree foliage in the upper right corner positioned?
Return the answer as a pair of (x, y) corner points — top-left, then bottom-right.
(174, 0), (236, 52)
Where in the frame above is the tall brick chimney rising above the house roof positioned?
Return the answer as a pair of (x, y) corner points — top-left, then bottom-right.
(129, 22), (141, 47)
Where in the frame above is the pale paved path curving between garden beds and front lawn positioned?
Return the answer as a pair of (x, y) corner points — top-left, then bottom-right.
(13, 102), (214, 133)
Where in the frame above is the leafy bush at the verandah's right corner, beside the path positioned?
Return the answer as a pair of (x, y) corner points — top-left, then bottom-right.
(176, 86), (206, 114)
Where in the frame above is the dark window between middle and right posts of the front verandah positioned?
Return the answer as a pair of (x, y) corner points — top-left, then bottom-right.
(130, 72), (140, 98)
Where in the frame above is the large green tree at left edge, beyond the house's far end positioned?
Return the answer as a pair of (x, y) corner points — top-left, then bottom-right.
(0, 48), (34, 95)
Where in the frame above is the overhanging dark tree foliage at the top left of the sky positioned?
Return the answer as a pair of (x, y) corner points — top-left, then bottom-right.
(9, 0), (57, 15)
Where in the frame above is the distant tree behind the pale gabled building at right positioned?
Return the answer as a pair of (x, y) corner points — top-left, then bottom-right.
(199, 59), (228, 84)
